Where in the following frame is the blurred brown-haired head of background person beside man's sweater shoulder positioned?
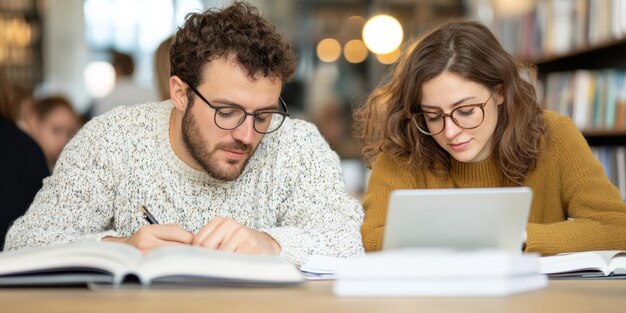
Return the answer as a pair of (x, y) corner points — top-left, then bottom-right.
(23, 96), (81, 171)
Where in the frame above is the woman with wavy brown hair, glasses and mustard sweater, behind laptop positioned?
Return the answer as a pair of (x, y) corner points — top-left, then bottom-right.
(355, 21), (626, 255)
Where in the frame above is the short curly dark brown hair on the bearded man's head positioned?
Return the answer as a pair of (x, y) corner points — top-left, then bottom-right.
(170, 2), (296, 93)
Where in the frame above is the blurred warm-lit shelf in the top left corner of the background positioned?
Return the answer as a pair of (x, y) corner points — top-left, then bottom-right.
(0, 0), (43, 89)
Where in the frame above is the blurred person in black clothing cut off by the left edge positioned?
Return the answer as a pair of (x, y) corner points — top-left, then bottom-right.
(0, 73), (50, 251)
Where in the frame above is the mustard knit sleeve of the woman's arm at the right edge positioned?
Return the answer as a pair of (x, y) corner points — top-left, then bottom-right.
(526, 114), (626, 255)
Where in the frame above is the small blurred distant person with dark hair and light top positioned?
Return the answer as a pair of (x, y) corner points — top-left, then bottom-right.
(92, 50), (159, 116)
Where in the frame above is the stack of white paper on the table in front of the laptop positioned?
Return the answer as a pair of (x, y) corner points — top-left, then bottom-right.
(333, 250), (547, 296)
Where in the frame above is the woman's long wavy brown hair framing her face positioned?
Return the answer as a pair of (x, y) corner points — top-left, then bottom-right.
(354, 19), (547, 185)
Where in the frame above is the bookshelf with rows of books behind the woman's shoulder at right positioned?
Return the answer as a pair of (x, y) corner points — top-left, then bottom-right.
(482, 0), (626, 199)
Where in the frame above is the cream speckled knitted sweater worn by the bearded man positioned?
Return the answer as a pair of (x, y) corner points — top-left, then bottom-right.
(5, 101), (363, 264)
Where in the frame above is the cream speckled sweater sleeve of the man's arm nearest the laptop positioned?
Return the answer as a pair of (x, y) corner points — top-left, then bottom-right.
(261, 122), (364, 264)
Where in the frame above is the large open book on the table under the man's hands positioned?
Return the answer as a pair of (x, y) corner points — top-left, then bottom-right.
(0, 241), (303, 286)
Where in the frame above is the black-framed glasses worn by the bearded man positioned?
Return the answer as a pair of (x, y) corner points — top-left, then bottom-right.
(185, 82), (289, 134)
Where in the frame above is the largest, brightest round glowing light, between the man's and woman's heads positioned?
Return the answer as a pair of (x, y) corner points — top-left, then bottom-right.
(363, 15), (403, 54)
